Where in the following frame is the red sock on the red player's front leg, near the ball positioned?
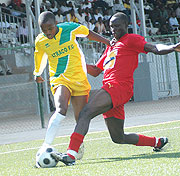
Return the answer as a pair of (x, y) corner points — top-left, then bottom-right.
(68, 132), (84, 159)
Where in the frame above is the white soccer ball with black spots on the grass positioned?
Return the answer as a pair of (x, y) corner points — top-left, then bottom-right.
(36, 146), (58, 168)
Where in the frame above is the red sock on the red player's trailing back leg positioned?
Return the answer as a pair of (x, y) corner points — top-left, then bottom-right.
(135, 134), (156, 147)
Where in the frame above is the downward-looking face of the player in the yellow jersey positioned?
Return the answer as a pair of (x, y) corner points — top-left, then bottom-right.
(40, 22), (58, 39)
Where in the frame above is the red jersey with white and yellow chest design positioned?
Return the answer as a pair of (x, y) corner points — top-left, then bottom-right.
(96, 34), (147, 87)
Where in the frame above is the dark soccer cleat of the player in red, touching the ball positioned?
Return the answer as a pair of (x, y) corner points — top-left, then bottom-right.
(51, 152), (75, 166)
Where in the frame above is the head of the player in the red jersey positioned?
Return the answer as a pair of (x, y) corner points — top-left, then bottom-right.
(109, 12), (129, 40)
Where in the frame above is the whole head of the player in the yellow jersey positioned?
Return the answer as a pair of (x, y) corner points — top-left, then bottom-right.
(38, 11), (58, 39)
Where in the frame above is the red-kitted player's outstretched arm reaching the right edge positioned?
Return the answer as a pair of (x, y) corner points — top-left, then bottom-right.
(144, 43), (180, 55)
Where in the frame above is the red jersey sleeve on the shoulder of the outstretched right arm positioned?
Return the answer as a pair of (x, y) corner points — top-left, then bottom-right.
(128, 34), (147, 54)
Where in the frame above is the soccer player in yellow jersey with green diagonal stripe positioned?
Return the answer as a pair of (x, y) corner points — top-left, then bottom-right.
(34, 11), (110, 166)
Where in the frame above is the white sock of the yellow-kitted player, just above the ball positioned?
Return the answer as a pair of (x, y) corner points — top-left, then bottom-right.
(44, 112), (66, 145)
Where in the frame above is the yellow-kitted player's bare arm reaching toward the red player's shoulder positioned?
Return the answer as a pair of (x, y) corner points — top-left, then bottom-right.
(87, 30), (110, 46)
